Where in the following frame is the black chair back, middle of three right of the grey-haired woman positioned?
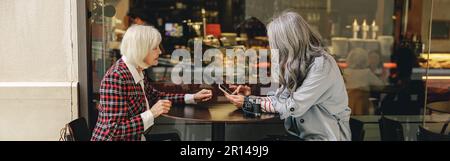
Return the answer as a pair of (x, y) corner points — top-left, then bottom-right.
(378, 116), (405, 141)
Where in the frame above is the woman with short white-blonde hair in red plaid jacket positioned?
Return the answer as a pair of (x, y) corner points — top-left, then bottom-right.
(91, 25), (212, 141)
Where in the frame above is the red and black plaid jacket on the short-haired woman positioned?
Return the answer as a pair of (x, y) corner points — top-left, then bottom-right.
(91, 59), (184, 141)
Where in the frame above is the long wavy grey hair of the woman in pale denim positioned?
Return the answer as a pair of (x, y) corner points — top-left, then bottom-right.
(267, 11), (328, 94)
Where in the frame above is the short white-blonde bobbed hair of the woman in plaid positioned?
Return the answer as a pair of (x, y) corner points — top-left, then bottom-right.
(120, 25), (161, 69)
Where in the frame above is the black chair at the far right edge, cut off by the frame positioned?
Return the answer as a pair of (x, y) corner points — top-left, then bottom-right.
(417, 121), (450, 141)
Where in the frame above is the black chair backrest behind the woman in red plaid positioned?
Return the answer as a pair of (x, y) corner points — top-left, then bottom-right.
(69, 117), (92, 141)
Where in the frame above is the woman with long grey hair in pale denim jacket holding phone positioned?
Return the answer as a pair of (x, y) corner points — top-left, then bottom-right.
(226, 12), (351, 141)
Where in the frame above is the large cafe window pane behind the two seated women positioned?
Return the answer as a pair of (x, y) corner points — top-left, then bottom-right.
(84, 0), (450, 140)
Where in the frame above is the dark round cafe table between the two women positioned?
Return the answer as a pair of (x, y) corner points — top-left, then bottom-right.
(163, 103), (277, 141)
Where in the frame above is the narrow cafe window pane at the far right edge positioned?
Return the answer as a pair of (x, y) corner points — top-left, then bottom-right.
(421, 0), (450, 141)
